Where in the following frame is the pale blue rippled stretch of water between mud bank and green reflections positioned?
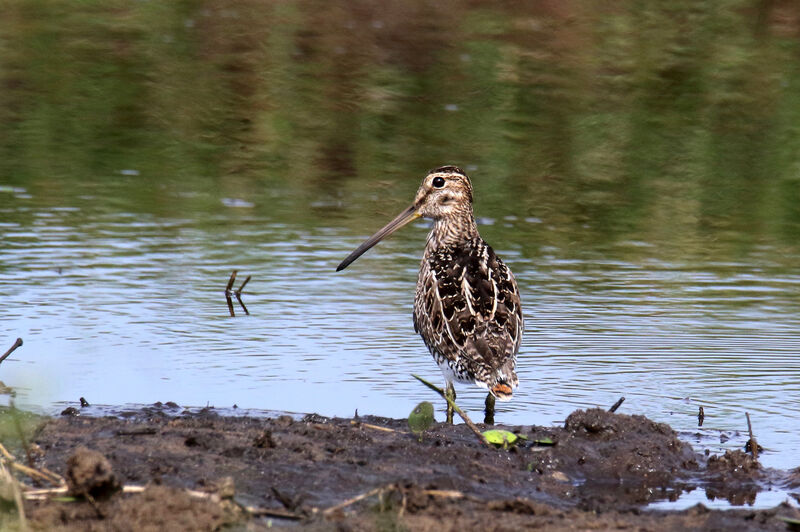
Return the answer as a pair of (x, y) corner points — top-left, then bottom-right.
(0, 211), (800, 468)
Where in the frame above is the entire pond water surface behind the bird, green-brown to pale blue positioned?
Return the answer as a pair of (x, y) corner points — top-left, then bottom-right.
(0, 1), (800, 482)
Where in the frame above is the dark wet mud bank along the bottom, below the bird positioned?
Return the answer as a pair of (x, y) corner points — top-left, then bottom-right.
(12, 407), (800, 531)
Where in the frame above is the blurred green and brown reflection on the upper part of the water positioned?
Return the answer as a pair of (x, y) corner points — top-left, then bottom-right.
(0, 0), (800, 261)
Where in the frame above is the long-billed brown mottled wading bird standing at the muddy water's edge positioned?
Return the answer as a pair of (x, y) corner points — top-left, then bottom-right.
(336, 165), (524, 424)
